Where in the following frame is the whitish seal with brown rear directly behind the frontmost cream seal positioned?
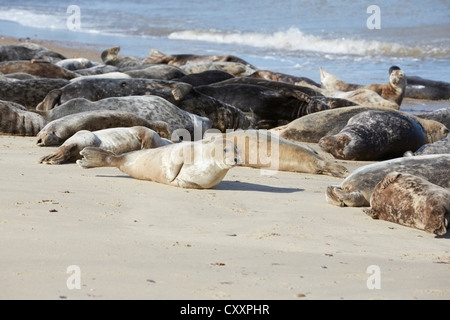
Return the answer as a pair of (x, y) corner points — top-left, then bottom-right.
(39, 126), (172, 164)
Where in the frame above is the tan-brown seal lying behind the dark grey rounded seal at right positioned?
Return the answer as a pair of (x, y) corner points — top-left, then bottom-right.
(270, 106), (449, 143)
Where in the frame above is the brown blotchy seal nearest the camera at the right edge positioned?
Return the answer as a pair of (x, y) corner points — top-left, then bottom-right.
(364, 171), (450, 235)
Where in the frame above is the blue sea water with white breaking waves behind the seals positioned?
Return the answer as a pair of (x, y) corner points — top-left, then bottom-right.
(0, 0), (450, 112)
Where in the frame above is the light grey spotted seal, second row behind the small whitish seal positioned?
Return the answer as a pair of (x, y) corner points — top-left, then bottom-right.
(39, 96), (211, 140)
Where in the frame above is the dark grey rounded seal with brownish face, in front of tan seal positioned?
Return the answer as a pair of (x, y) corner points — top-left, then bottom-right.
(319, 110), (427, 161)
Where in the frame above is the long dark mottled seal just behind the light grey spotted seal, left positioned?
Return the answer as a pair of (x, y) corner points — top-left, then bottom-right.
(36, 78), (192, 110)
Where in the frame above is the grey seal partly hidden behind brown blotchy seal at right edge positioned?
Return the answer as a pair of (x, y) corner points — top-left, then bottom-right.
(326, 154), (450, 207)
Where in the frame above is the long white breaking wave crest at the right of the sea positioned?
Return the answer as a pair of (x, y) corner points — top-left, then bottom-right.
(168, 28), (450, 59)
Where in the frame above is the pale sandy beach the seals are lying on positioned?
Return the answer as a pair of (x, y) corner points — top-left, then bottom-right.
(0, 38), (450, 300)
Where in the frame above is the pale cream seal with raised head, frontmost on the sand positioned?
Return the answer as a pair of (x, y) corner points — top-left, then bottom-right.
(77, 139), (240, 189)
